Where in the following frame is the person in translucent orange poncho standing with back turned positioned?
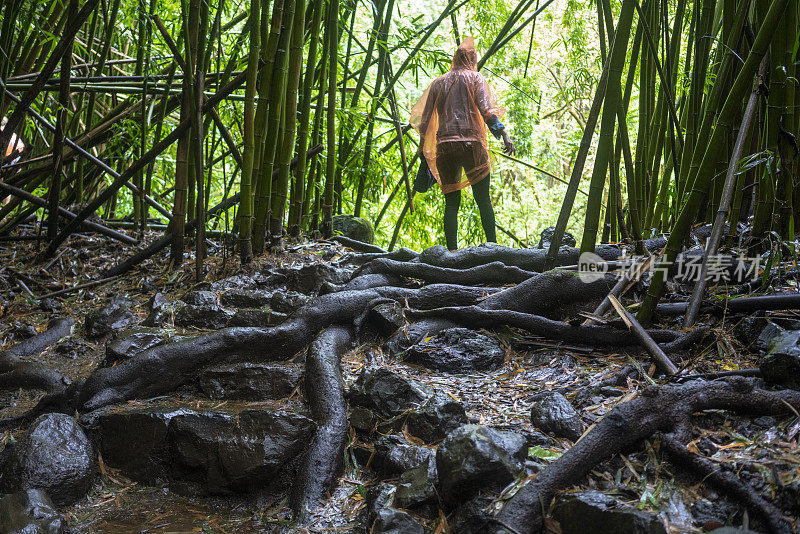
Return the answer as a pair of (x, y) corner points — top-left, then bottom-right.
(410, 37), (516, 251)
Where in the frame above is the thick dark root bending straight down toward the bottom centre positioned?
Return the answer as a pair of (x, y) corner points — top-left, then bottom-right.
(290, 326), (353, 522)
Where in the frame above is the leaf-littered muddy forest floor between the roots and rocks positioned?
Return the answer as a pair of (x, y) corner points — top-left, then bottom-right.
(0, 234), (800, 534)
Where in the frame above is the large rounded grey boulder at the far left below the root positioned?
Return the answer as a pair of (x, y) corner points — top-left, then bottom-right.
(0, 413), (95, 506)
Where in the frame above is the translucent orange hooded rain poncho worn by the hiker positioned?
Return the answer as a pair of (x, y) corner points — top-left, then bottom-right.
(409, 37), (504, 193)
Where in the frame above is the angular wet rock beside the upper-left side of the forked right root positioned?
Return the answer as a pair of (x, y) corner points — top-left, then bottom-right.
(436, 425), (528, 503)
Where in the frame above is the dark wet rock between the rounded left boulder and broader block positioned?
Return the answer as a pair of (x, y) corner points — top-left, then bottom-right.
(81, 407), (194, 484)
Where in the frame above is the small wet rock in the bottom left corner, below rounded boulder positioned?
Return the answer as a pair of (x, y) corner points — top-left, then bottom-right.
(0, 489), (64, 534)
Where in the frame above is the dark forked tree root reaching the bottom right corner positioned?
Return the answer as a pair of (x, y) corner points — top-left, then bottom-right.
(495, 377), (800, 534)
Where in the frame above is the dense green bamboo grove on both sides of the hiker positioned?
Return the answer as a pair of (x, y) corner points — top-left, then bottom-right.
(0, 0), (800, 320)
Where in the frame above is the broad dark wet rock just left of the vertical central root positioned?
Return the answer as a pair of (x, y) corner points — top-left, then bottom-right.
(169, 410), (314, 492)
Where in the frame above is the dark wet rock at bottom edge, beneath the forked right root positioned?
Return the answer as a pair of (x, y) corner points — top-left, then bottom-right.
(553, 490), (666, 534)
